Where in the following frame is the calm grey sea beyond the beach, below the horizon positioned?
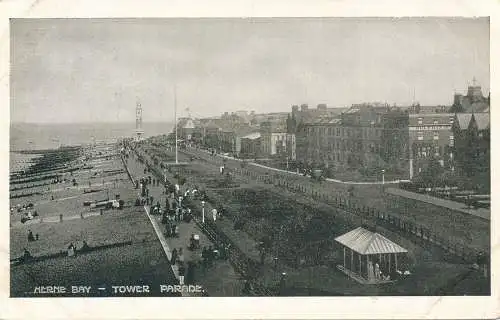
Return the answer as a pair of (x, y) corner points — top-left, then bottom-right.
(9, 122), (174, 172)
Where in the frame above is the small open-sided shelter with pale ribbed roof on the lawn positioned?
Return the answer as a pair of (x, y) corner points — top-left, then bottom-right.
(335, 227), (408, 284)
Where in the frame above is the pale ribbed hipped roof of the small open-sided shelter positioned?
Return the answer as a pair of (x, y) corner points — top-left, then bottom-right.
(335, 227), (408, 255)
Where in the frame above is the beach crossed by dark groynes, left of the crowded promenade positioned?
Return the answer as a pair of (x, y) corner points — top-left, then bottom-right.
(10, 144), (175, 297)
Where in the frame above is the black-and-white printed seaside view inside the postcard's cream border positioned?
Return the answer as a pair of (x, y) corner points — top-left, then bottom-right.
(0, 1), (494, 318)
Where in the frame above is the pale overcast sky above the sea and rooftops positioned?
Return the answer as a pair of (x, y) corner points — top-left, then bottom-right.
(11, 18), (490, 123)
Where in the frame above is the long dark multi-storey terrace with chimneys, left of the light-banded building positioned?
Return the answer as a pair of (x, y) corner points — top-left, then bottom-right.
(296, 104), (408, 169)
